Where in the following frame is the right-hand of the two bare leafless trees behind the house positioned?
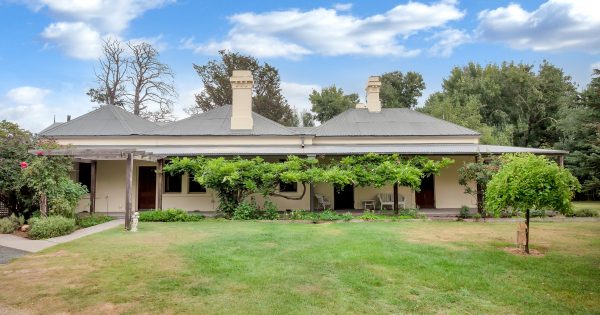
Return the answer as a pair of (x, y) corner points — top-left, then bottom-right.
(127, 42), (177, 121)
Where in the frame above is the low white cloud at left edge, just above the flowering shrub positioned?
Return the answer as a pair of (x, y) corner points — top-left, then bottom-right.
(0, 86), (51, 131)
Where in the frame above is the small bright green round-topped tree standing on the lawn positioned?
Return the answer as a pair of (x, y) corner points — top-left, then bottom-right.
(485, 154), (581, 254)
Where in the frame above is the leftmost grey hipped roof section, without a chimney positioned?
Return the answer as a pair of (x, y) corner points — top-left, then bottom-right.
(40, 105), (158, 137)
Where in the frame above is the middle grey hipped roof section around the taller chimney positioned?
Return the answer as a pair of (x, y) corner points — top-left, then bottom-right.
(146, 105), (295, 136)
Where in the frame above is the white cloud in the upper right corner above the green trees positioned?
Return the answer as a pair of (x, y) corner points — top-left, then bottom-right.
(477, 0), (600, 53)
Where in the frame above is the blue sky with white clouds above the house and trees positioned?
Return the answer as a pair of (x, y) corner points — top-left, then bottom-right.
(0, 0), (600, 132)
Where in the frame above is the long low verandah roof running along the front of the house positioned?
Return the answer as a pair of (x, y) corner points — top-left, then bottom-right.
(59, 144), (568, 156)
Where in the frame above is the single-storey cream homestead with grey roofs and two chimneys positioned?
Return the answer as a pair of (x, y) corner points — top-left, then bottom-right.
(40, 71), (566, 212)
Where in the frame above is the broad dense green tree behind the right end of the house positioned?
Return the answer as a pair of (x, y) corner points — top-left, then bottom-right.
(422, 61), (577, 147)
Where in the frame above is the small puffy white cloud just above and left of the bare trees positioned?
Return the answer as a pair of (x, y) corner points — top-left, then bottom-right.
(42, 22), (102, 59)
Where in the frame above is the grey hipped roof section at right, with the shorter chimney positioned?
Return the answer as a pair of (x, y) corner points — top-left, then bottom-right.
(314, 108), (479, 137)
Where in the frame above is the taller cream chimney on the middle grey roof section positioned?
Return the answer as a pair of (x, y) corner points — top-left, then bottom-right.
(229, 70), (254, 130)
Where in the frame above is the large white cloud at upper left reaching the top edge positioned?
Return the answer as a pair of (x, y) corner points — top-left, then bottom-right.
(27, 0), (174, 59)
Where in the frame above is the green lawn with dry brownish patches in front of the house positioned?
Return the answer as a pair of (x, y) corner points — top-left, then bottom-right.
(0, 220), (600, 314)
